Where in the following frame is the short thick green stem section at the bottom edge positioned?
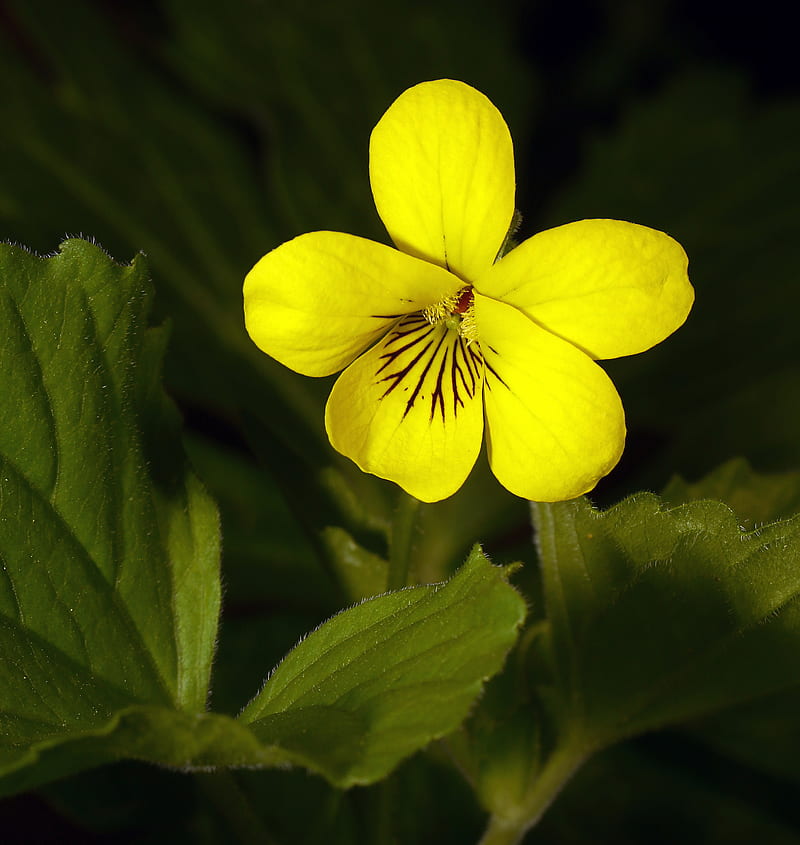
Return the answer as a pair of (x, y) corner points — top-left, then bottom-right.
(478, 746), (587, 845)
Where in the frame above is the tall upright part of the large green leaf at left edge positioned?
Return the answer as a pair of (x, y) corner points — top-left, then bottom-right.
(0, 240), (220, 792)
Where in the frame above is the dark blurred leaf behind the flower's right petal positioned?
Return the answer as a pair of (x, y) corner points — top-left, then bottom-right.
(546, 70), (800, 490)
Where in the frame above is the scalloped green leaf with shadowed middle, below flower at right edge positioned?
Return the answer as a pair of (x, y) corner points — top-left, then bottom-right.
(533, 494), (800, 748)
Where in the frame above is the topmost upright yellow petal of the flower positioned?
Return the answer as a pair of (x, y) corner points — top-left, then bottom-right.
(369, 79), (514, 281)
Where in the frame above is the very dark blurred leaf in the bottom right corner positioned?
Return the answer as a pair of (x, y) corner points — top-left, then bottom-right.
(536, 735), (800, 845)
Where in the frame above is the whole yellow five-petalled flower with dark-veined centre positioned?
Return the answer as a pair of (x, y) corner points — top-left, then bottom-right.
(244, 79), (694, 502)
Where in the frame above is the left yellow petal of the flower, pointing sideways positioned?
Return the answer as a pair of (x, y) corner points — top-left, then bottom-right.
(244, 232), (462, 376)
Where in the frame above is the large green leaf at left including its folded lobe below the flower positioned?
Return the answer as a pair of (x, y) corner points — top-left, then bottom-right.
(0, 296), (525, 793)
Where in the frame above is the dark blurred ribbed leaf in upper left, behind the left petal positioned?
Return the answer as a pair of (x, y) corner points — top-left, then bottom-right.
(0, 0), (324, 454)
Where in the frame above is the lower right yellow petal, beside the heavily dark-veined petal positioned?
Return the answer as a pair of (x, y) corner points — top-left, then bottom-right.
(475, 294), (625, 502)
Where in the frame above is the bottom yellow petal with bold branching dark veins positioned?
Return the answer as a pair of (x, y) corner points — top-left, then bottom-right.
(325, 314), (483, 502)
